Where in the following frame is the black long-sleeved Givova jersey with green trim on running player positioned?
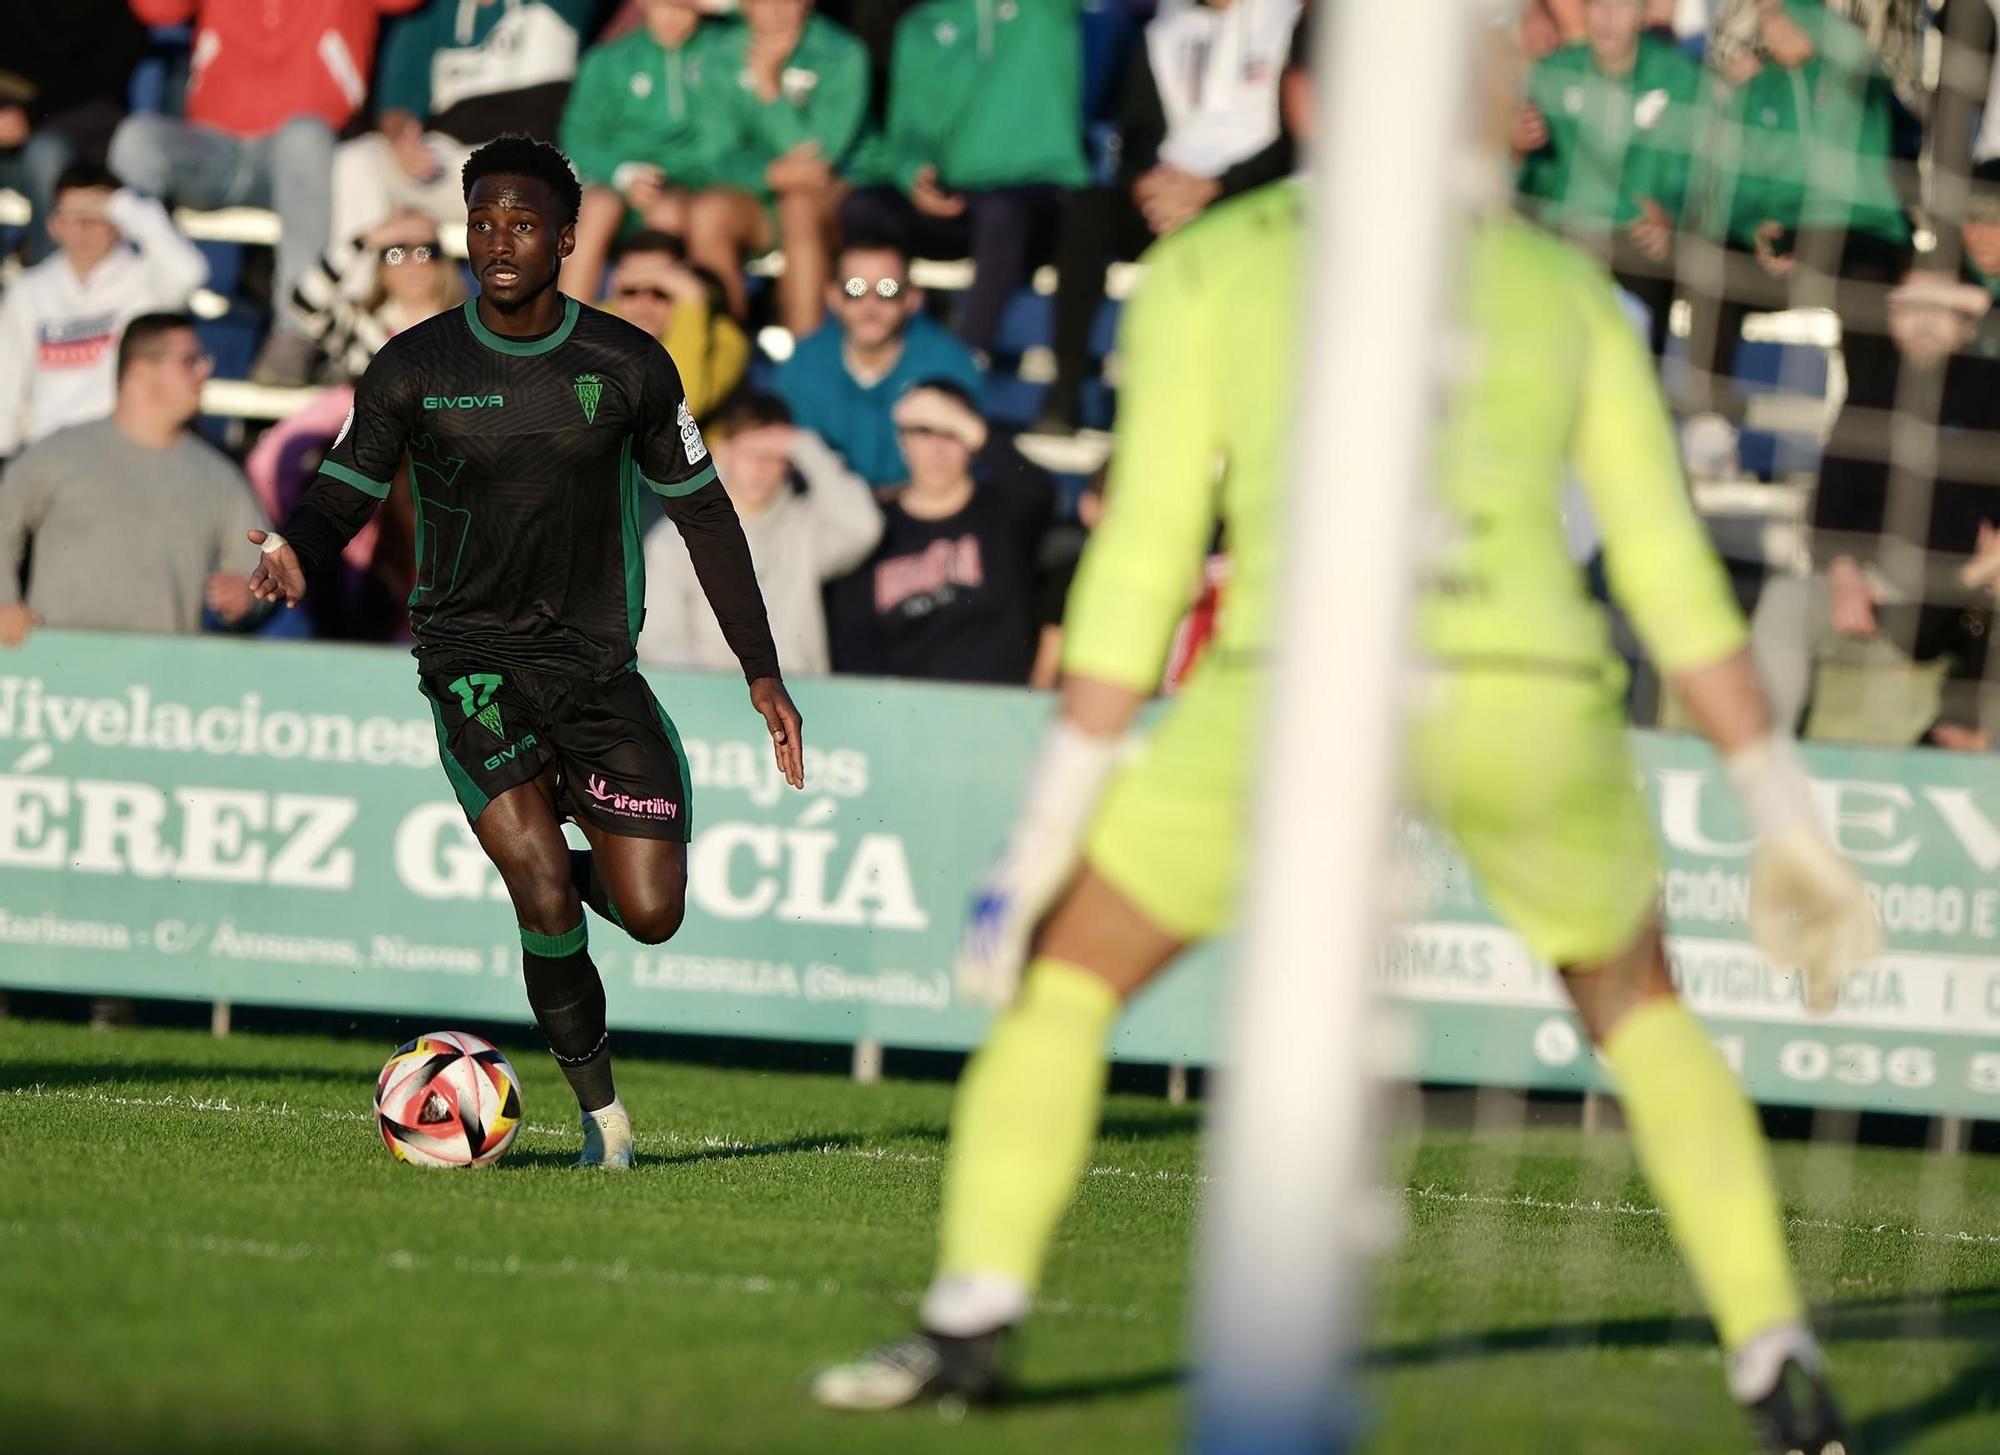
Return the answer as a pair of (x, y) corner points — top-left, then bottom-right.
(284, 298), (778, 680)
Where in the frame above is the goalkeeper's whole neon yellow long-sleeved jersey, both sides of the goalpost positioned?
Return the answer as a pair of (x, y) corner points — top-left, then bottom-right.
(1064, 182), (1744, 692)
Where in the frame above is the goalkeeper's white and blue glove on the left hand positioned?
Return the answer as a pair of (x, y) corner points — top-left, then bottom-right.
(956, 720), (1120, 1007)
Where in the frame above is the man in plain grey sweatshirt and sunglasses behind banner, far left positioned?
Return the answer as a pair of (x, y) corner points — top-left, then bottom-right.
(0, 314), (270, 646)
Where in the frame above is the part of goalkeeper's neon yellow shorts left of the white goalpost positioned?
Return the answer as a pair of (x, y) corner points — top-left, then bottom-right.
(1084, 658), (1262, 939)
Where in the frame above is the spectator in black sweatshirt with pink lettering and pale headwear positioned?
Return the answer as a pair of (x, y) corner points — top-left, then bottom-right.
(830, 380), (1056, 684)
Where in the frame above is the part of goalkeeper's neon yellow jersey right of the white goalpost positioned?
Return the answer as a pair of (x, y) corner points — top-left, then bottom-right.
(1424, 218), (1746, 674)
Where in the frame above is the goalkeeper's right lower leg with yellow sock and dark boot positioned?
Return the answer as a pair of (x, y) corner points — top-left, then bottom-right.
(1562, 923), (1852, 1455)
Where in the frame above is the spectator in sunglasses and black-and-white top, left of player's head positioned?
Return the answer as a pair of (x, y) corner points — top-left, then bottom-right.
(292, 212), (466, 380)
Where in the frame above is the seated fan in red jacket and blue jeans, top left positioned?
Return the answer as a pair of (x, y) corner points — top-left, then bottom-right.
(110, 0), (420, 384)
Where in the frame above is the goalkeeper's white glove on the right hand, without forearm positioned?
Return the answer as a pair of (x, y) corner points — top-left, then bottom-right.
(1724, 735), (1882, 1015)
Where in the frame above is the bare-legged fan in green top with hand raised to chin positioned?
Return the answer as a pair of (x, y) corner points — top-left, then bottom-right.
(688, 0), (868, 336)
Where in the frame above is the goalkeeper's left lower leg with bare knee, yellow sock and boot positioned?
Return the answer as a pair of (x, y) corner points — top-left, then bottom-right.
(814, 865), (1184, 1409)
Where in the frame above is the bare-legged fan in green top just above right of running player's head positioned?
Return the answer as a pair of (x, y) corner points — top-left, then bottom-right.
(562, 0), (726, 302)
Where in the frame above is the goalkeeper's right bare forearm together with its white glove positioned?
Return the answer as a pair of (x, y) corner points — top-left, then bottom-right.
(1668, 650), (1882, 1015)
